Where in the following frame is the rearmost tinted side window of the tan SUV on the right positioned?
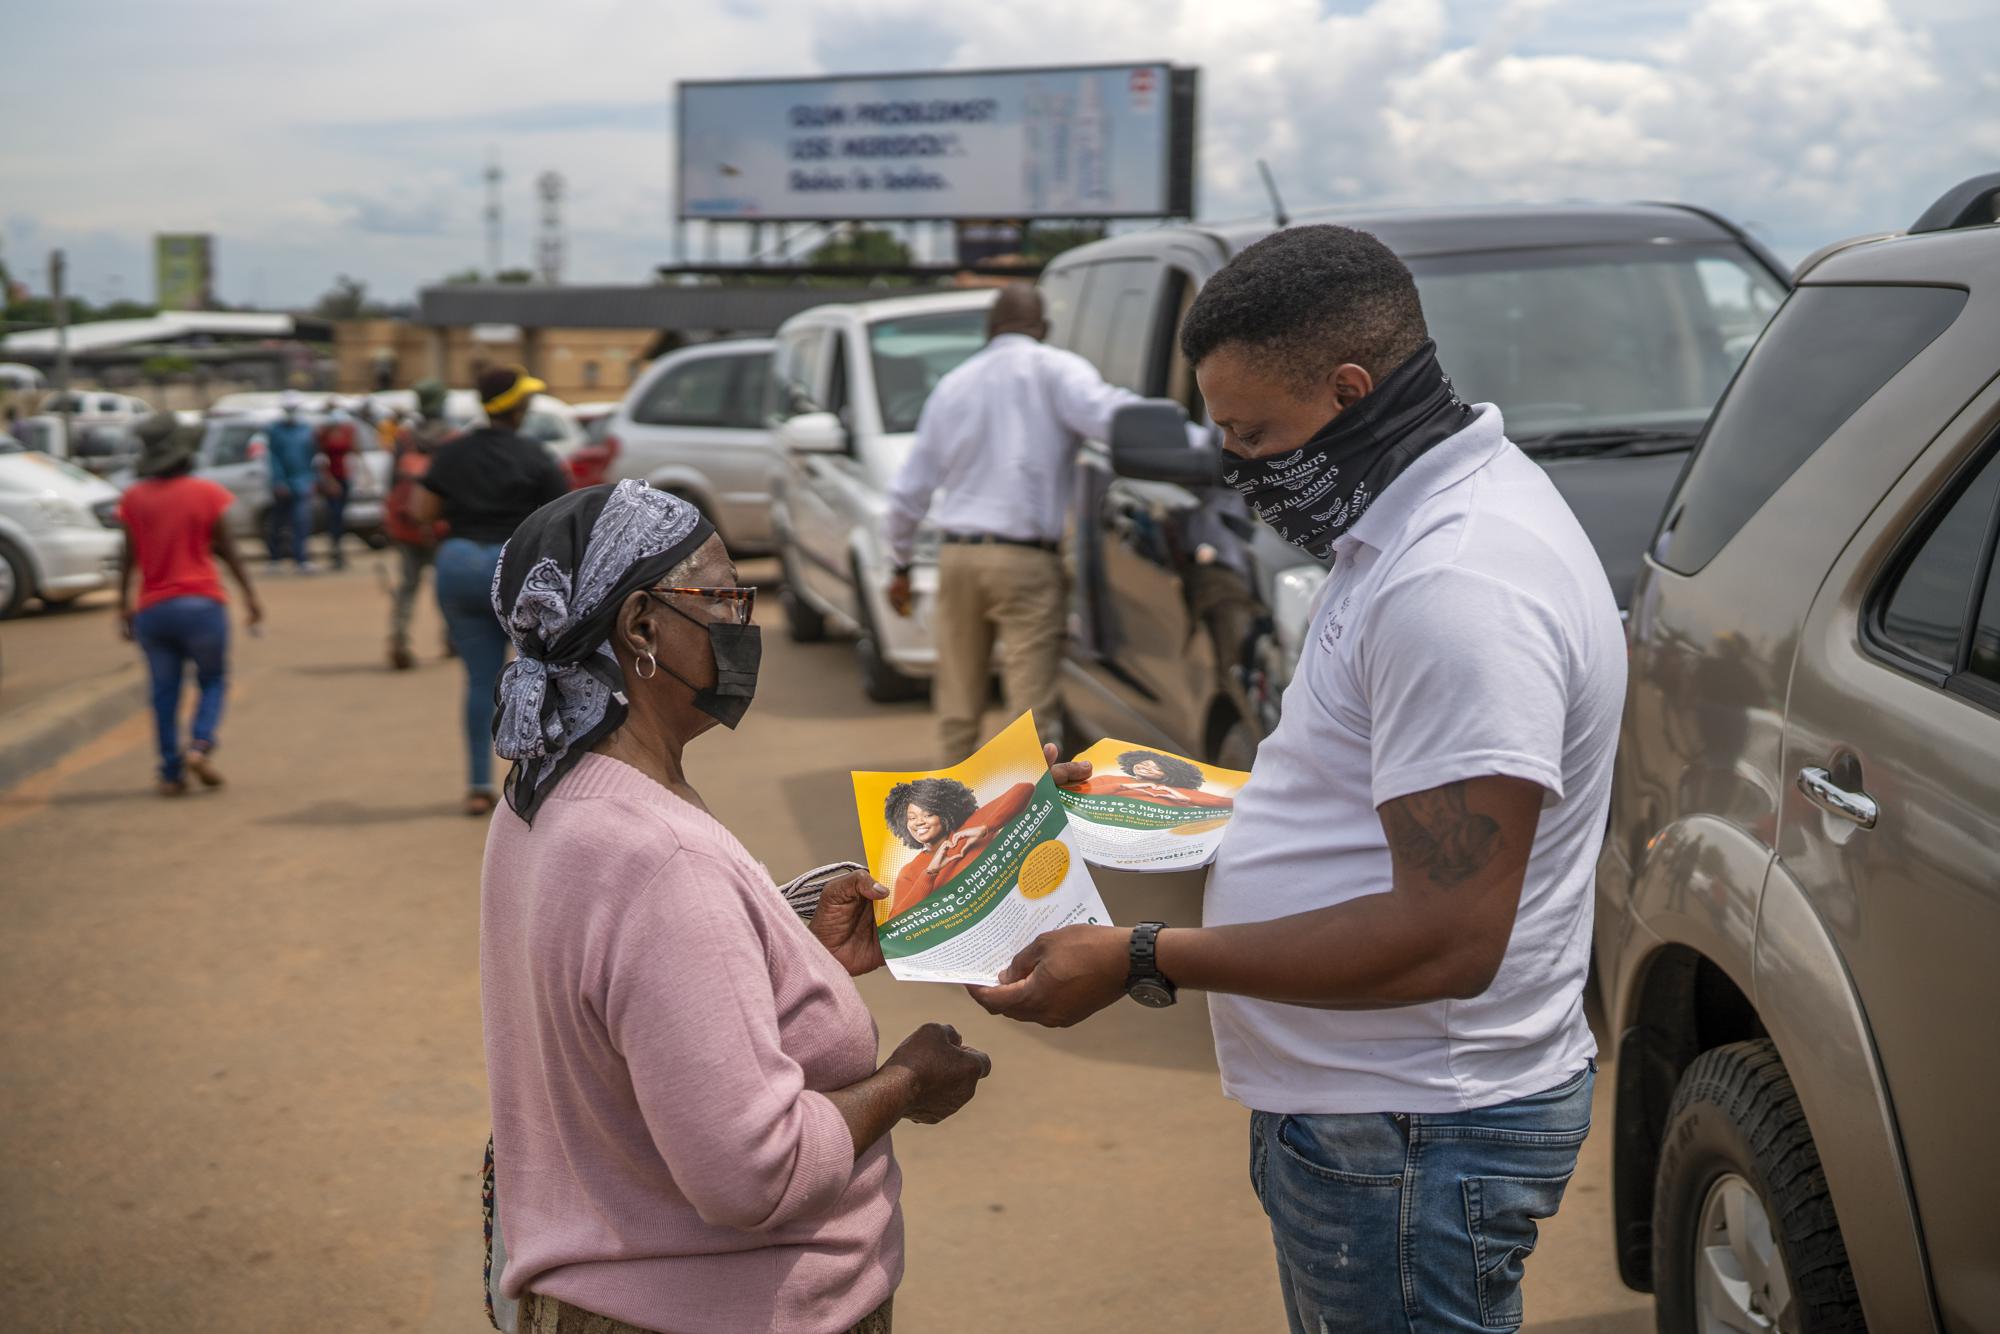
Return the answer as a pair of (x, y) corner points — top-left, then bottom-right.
(1654, 286), (1966, 574)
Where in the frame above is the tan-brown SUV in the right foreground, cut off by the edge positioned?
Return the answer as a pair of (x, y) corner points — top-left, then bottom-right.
(1596, 174), (2000, 1334)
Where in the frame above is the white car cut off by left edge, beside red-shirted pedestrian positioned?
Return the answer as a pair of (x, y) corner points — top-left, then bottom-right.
(0, 448), (124, 620)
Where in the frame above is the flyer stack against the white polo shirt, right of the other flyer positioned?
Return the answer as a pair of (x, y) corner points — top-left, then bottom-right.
(1056, 740), (1250, 870)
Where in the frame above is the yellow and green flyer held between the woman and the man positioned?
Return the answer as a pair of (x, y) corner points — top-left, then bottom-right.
(854, 714), (1110, 984)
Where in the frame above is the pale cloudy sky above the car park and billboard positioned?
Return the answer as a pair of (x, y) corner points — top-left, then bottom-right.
(0, 0), (2000, 304)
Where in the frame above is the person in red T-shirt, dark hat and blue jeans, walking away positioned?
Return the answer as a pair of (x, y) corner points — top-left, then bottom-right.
(118, 412), (264, 796)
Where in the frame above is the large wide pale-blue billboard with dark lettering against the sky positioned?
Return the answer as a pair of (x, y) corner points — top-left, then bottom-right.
(678, 64), (1196, 222)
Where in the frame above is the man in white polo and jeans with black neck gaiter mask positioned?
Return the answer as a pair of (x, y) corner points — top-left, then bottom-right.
(974, 226), (1626, 1334)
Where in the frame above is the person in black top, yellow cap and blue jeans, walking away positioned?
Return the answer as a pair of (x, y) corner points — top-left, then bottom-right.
(410, 366), (570, 816)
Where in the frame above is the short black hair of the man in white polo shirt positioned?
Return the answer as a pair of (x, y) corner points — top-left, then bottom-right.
(1180, 224), (1430, 386)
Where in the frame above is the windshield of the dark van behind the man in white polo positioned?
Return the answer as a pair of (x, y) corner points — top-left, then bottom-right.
(1410, 244), (1784, 446)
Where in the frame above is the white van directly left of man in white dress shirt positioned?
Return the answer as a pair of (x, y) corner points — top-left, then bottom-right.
(766, 288), (996, 702)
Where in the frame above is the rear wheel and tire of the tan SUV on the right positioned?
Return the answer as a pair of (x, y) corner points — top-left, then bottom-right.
(1652, 1040), (1868, 1334)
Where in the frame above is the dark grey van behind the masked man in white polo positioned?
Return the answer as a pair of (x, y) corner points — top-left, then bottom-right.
(1042, 204), (1788, 768)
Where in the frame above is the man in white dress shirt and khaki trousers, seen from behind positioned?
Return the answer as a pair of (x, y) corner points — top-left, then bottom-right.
(888, 284), (1138, 764)
